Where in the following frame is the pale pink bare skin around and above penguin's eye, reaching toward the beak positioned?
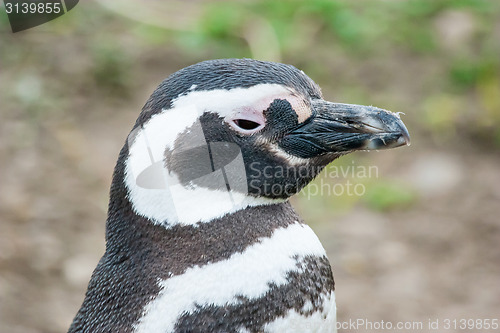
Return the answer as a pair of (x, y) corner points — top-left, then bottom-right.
(228, 94), (312, 134)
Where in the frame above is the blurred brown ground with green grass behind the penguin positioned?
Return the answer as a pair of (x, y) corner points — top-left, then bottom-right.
(0, 0), (500, 333)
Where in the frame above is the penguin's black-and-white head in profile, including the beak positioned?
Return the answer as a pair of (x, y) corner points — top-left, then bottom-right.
(119, 59), (409, 224)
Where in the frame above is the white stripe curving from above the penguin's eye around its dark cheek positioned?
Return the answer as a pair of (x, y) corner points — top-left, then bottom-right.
(125, 84), (302, 226)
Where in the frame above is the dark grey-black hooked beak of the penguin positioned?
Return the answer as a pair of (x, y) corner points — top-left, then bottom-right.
(280, 100), (410, 158)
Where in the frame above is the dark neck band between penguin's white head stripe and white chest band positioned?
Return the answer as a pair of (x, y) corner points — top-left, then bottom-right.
(106, 182), (303, 279)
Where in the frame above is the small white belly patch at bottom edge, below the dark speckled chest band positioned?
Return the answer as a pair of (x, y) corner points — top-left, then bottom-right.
(264, 292), (337, 333)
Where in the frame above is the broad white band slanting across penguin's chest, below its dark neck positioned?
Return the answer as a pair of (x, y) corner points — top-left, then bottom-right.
(135, 223), (325, 333)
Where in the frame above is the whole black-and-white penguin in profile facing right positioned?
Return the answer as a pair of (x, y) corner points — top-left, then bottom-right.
(68, 59), (410, 333)
